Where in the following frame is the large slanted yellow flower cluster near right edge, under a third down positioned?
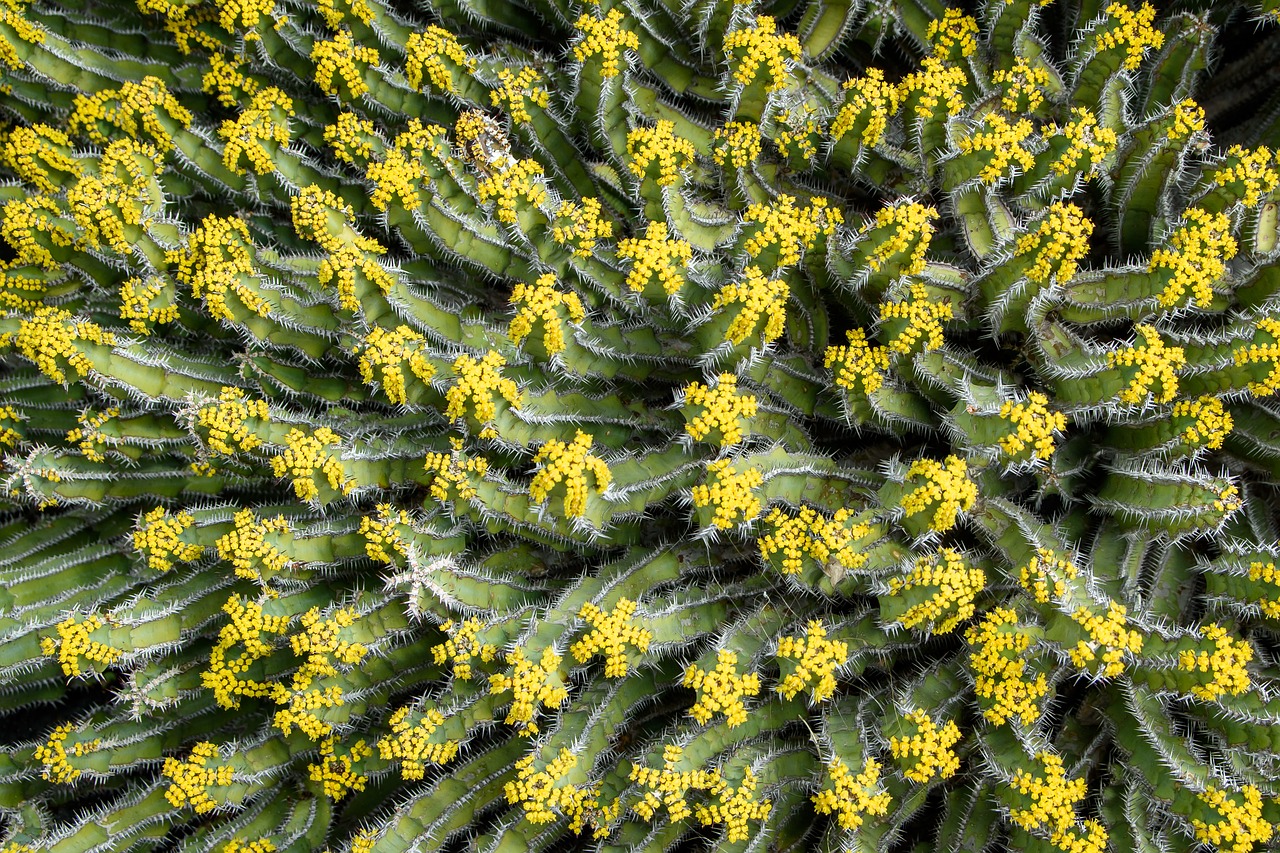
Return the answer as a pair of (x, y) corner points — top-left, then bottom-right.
(1147, 207), (1236, 307)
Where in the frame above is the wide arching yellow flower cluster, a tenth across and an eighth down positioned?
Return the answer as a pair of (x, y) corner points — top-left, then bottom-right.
(67, 77), (192, 154)
